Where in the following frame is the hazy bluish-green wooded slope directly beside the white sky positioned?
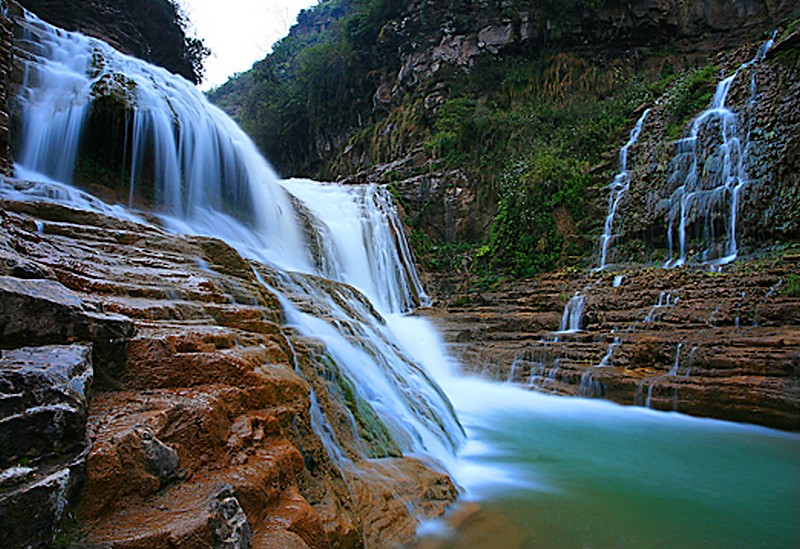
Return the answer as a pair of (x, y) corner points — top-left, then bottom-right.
(210, 0), (403, 174)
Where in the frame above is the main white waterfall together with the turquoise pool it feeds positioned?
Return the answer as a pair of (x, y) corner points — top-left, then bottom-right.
(7, 9), (800, 548)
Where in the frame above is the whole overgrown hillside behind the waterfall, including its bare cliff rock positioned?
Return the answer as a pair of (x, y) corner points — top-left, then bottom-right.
(211, 0), (796, 280)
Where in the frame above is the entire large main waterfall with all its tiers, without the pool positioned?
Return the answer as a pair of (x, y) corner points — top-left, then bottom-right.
(9, 6), (463, 474)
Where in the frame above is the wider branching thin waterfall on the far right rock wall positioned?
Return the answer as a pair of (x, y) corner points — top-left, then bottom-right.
(665, 40), (773, 267)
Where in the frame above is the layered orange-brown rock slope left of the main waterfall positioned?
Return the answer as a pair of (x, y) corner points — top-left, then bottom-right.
(0, 186), (456, 548)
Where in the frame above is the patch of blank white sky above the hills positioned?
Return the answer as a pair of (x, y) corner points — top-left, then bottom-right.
(179, 0), (317, 90)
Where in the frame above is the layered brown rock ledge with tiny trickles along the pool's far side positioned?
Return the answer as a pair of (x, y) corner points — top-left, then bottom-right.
(424, 260), (800, 430)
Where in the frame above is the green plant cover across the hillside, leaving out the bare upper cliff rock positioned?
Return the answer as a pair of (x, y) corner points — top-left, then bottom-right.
(211, 0), (744, 278)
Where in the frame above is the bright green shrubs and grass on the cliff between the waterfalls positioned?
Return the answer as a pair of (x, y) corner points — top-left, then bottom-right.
(406, 53), (669, 277)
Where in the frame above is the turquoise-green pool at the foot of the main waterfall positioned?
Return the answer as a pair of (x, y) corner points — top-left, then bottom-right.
(438, 379), (800, 548)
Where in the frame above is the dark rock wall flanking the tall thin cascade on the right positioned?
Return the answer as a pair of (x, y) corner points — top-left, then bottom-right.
(610, 29), (800, 263)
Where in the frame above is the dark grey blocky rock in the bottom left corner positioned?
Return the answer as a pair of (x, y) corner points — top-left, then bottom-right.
(0, 345), (92, 547)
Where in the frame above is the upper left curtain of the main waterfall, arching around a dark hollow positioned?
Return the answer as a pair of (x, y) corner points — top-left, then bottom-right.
(16, 8), (311, 272)
